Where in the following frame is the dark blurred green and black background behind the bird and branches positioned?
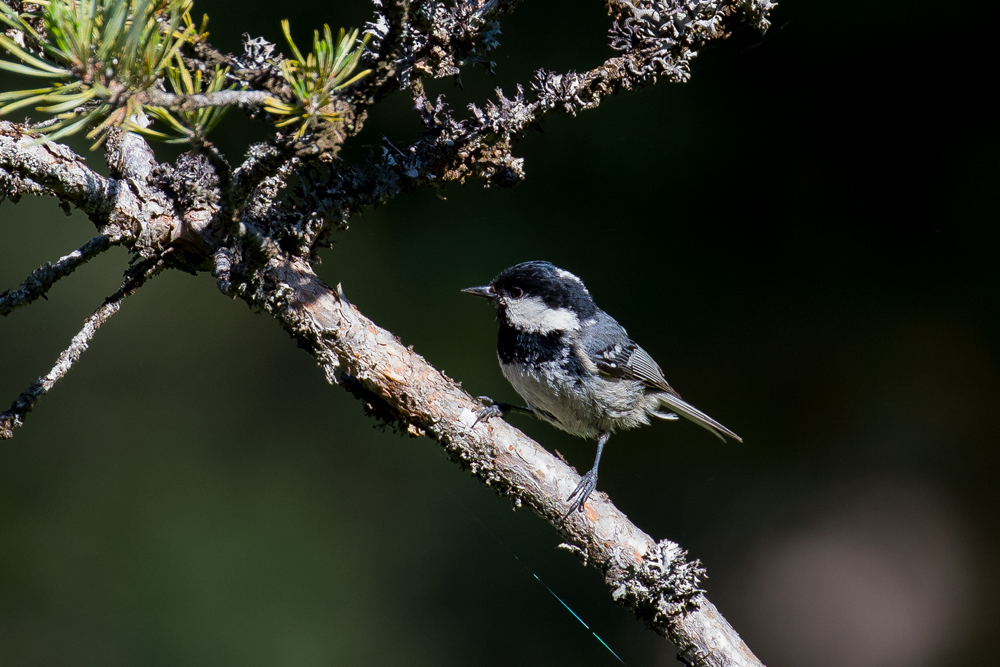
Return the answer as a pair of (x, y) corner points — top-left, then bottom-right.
(0, 0), (1000, 667)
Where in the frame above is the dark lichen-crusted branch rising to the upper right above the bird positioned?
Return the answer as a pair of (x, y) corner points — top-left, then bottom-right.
(276, 0), (774, 242)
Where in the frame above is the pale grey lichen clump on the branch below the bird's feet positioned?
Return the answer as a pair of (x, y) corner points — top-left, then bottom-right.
(608, 540), (706, 633)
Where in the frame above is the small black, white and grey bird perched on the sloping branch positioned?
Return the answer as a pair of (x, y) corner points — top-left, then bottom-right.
(462, 262), (743, 516)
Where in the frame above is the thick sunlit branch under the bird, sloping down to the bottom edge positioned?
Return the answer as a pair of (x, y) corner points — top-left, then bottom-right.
(243, 257), (762, 667)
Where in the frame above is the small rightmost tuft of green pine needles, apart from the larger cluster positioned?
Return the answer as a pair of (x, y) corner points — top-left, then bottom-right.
(264, 21), (371, 139)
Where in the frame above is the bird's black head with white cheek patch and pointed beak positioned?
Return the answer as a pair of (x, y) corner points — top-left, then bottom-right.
(462, 261), (597, 330)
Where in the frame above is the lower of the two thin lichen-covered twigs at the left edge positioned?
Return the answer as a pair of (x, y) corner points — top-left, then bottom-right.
(0, 251), (169, 440)
